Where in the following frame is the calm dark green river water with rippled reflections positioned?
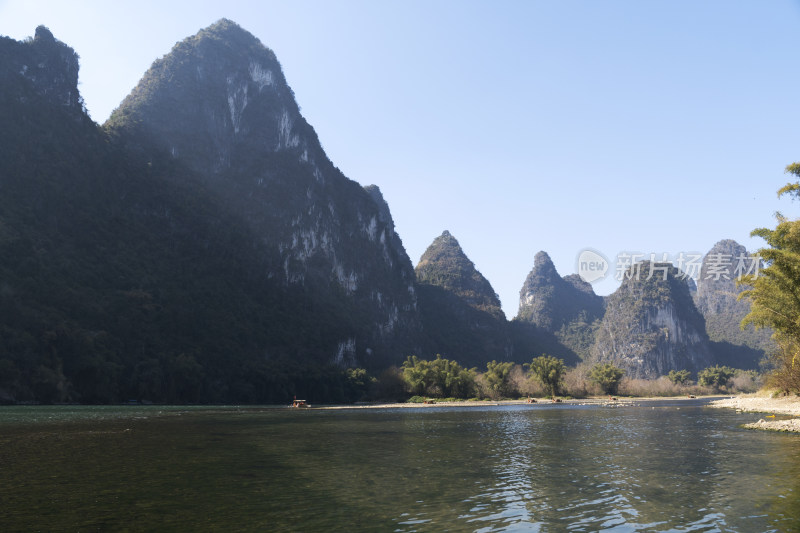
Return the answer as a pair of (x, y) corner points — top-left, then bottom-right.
(0, 400), (800, 532)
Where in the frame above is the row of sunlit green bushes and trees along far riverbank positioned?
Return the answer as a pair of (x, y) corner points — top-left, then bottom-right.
(308, 355), (763, 404)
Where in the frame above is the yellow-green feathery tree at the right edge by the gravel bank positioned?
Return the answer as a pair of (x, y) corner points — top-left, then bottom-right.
(737, 163), (800, 394)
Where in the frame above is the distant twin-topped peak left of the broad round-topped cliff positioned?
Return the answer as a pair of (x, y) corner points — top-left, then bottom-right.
(515, 252), (603, 357)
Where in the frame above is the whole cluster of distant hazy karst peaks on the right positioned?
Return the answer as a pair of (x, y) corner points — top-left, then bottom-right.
(514, 240), (772, 378)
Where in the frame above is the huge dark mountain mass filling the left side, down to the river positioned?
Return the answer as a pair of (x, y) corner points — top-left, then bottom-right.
(0, 21), (420, 402)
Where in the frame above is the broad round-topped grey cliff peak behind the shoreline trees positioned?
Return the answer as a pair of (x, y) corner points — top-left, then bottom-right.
(591, 261), (712, 378)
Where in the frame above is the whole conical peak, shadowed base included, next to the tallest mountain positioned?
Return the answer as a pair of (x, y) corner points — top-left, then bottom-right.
(416, 231), (513, 366)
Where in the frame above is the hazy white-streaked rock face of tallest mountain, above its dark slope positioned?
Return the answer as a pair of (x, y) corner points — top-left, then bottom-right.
(106, 20), (419, 365)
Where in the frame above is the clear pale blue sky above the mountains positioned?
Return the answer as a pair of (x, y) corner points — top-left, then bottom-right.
(0, 0), (800, 318)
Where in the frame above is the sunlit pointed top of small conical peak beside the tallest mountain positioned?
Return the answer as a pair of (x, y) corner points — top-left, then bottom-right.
(416, 230), (505, 318)
